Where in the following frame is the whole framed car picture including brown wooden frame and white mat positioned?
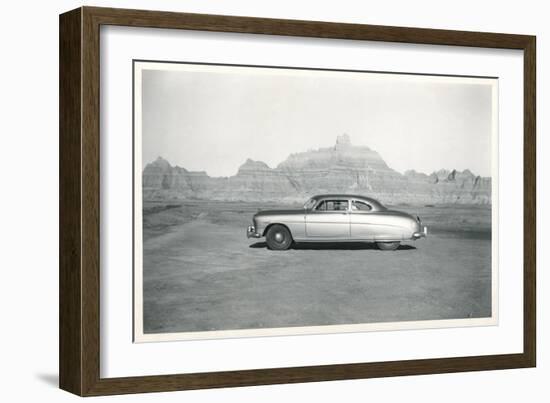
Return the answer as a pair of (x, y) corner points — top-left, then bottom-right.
(60, 7), (536, 396)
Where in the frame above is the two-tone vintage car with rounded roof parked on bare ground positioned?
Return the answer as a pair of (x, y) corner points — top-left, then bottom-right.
(246, 195), (428, 250)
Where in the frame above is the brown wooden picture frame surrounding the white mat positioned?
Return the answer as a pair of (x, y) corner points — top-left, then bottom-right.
(59, 7), (536, 396)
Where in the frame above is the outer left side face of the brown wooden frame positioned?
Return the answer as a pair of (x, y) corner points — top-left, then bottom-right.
(59, 10), (83, 394)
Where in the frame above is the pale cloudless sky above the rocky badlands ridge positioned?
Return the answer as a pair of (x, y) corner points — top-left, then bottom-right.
(140, 63), (497, 176)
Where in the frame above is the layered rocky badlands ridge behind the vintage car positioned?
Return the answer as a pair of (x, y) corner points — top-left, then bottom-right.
(143, 134), (491, 204)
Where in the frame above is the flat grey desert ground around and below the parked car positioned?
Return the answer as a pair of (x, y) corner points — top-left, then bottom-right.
(143, 200), (491, 333)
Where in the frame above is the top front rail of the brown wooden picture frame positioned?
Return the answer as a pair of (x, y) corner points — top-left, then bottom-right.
(85, 7), (529, 49)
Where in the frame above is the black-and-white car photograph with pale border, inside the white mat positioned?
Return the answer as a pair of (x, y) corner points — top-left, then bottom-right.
(133, 60), (498, 342)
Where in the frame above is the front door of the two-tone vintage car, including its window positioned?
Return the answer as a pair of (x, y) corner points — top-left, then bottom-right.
(306, 199), (350, 239)
